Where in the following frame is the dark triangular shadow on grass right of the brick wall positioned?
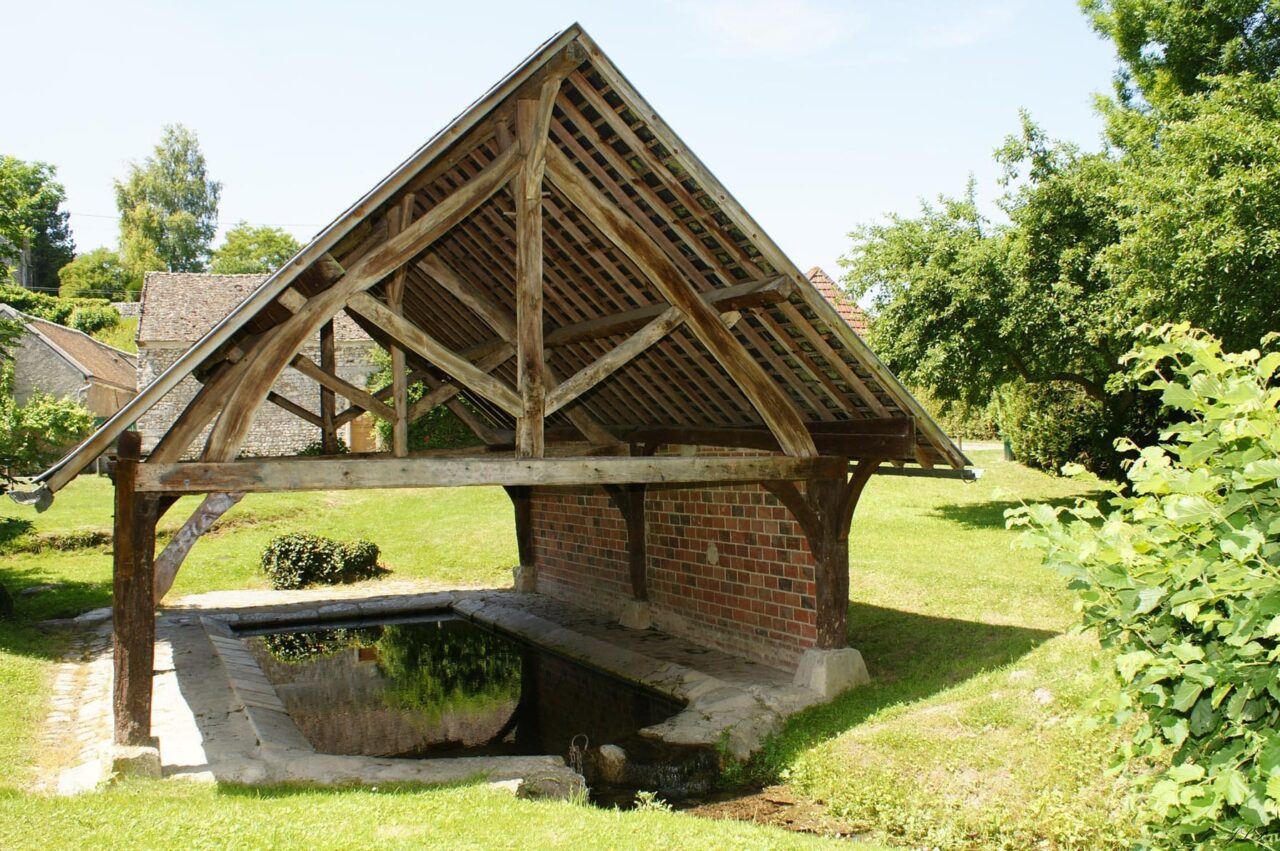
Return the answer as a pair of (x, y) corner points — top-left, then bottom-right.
(745, 603), (1059, 784)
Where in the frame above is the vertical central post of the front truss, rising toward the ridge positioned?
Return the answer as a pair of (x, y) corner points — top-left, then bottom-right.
(511, 76), (561, 458)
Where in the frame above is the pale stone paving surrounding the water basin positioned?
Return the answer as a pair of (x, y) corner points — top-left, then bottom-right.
(41, 581), (822, 795)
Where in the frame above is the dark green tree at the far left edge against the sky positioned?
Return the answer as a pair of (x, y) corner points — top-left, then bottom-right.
(0, 155), (76, 292)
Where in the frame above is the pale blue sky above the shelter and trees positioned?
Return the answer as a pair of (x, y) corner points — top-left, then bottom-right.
(0, 0), (1115, 285)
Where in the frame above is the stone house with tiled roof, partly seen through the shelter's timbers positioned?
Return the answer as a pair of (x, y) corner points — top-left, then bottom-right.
(137, 271), (378, 456)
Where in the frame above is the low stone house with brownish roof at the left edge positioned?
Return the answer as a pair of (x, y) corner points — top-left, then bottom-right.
(0, 305), (137, 420)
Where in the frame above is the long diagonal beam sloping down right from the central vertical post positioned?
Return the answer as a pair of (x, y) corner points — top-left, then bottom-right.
(547, 146), (818, 457)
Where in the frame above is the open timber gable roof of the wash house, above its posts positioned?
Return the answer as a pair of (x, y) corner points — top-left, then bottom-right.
(17, 24), (968, 500)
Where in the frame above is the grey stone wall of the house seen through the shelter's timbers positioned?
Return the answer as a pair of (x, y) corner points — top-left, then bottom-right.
(138, 342), (375, 457)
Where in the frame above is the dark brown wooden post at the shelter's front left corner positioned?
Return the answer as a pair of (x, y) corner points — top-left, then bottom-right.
(111, 431), (159, 745)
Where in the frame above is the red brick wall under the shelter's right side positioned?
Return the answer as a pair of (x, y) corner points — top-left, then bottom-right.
(532, 485), (817, 668)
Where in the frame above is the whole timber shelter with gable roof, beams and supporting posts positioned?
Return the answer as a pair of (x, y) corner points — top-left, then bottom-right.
(15, 24), (968, 744)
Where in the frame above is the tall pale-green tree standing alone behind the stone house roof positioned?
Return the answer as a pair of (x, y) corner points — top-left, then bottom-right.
(115, 124), (223, 287)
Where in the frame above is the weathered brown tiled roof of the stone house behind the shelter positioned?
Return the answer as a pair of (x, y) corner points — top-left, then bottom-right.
(138, 271), (369, 344)
